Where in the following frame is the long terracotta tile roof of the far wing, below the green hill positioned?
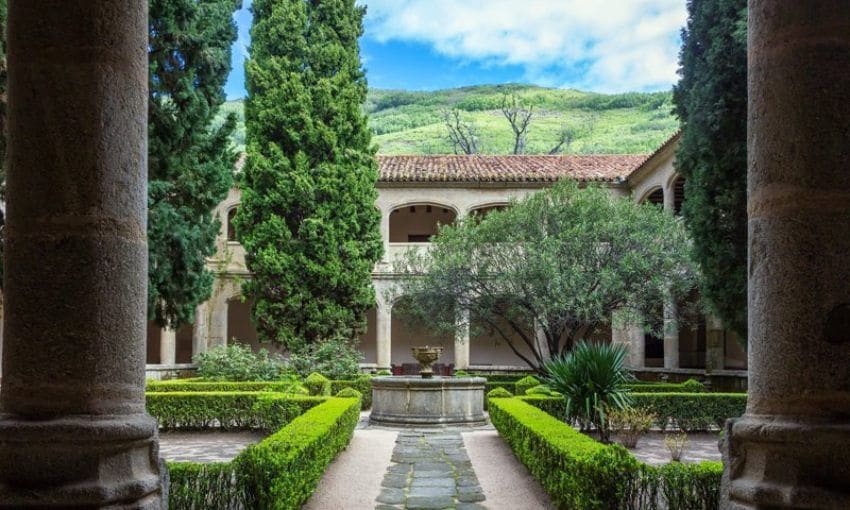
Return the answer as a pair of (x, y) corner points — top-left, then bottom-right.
(378, 154), (647, 182)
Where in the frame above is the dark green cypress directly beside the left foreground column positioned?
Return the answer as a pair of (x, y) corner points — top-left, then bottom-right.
(148, 0), (241, 327)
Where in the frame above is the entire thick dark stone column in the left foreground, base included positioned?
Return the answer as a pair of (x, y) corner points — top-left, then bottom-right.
(0, 0), (166, 509)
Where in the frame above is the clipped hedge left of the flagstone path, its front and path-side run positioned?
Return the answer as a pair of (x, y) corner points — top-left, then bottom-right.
(168, 398), (360, 510)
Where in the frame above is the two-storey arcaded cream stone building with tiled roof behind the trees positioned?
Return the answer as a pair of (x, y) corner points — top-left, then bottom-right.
(142, 134), (746, 377)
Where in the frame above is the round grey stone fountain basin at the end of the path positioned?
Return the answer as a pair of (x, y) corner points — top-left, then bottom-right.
(369, 376), (487, 427)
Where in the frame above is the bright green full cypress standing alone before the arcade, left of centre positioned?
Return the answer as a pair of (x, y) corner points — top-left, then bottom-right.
(236, 0), (383, 348)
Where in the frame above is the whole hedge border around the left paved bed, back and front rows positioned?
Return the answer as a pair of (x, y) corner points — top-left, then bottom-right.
(147, 391), (360, 510)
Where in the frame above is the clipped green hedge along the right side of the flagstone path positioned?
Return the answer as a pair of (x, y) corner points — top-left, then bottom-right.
(490, 398), (723, 510)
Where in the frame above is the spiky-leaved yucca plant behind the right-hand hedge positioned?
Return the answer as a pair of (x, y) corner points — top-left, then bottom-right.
(543, 341), (634, 443)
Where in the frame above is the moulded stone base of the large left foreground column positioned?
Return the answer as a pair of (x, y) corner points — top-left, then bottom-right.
(0, 414), (167, 510)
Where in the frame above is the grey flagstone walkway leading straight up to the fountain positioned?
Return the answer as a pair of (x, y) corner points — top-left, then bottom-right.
(375, 430), (486, 510)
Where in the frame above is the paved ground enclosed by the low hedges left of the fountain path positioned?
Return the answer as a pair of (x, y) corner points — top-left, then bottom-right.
(159, 432), (266, 462)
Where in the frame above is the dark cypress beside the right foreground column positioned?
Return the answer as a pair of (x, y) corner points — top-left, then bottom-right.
(673, 0), (747, 337)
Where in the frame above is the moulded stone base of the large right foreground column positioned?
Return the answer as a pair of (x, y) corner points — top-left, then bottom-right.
(721, 415), (850, 510)
